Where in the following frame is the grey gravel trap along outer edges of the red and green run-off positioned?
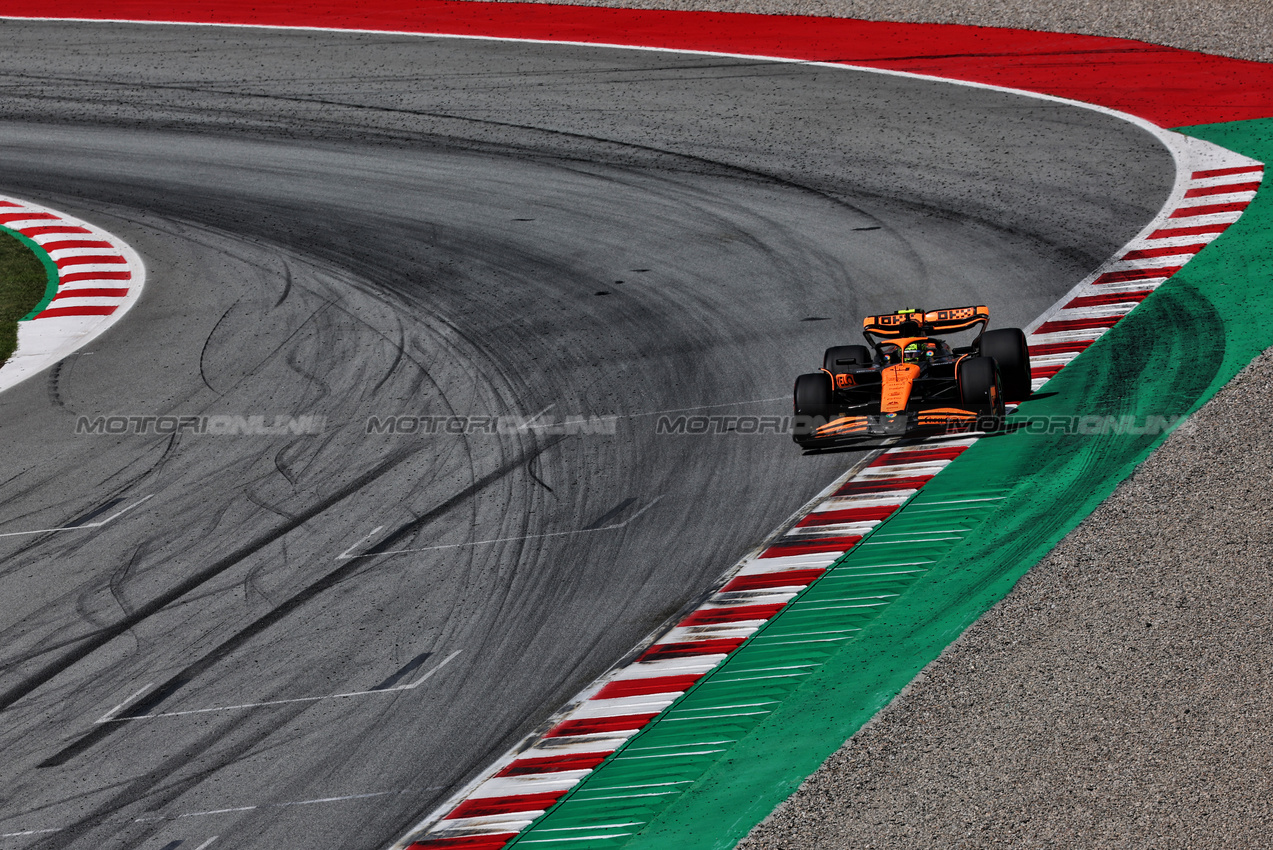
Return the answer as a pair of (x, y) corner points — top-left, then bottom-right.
(488, 0), (1273, 850)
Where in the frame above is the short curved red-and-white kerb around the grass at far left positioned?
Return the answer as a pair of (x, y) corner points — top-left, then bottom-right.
(0, 197), (146, 391)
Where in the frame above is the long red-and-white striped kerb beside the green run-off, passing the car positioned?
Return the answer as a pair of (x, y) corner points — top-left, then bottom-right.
(395, 82), (1264, 850)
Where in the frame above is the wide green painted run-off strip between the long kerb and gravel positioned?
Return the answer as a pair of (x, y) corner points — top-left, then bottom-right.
(509, 120), (1273, 850)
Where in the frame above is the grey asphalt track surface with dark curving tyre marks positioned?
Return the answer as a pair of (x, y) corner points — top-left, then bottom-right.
(0, 22), (1172, 850)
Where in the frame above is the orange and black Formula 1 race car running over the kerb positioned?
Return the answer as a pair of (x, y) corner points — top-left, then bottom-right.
(794, 307), (1030, 448)
